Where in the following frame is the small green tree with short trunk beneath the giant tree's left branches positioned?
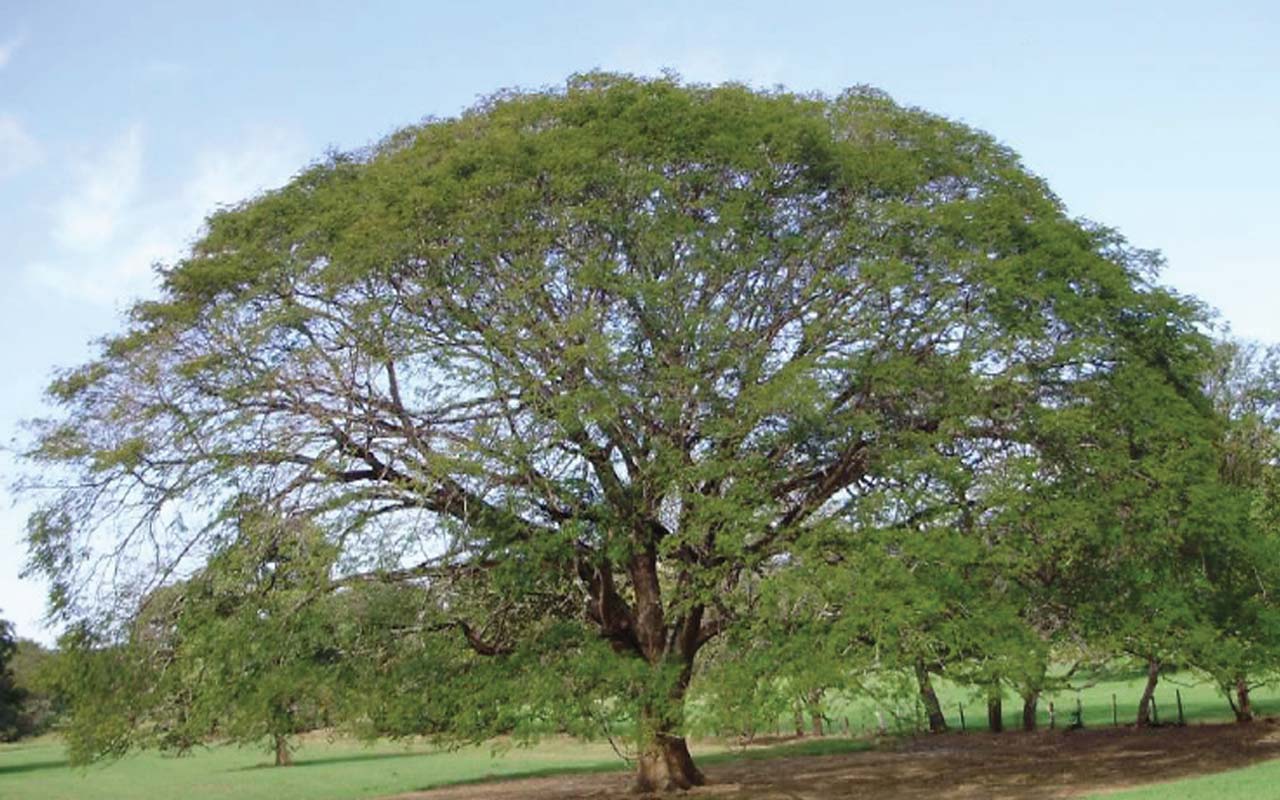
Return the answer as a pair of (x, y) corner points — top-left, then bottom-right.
(168, 511), (342, 767)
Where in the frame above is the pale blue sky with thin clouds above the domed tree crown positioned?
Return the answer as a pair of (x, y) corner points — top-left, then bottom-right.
(0, 0), (1280, 640)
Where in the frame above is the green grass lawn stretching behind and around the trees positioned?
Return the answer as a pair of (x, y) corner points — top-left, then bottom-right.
(0, 678), (1280, 800)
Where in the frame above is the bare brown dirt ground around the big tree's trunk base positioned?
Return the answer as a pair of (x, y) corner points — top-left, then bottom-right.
(384, 719), (1280, 800)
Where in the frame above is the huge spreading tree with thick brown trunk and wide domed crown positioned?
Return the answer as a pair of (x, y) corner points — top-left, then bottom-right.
(29, 74), (1203, 788)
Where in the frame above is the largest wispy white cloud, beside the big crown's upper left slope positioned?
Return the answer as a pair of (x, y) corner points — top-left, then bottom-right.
(27, 127), (303, 305)
